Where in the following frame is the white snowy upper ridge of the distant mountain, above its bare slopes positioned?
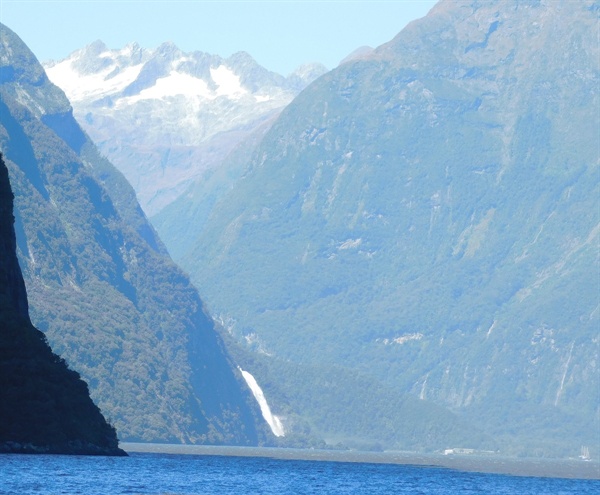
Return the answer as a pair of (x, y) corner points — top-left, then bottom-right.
(45, 41), (312, 107)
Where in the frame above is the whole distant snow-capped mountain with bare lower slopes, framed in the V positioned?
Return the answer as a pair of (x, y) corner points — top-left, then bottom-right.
(45, 45), (325, 215)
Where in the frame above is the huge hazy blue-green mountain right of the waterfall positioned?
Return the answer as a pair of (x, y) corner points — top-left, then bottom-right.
(156, 0), (600, 458)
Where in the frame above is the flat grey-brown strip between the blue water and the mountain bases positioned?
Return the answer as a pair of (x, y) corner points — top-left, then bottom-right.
(120, 442), (600, 480)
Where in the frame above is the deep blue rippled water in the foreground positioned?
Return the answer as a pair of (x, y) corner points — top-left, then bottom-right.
(0, 445), (600, 495)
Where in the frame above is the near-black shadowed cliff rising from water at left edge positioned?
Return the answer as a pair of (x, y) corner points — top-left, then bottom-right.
(0, 155), (125, 455)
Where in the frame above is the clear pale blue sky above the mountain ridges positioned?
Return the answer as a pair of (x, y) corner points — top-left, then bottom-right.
(0, 0), (436, 75)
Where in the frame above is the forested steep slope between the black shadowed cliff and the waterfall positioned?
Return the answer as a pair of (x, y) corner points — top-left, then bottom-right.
(0, 25), (270, 444)
